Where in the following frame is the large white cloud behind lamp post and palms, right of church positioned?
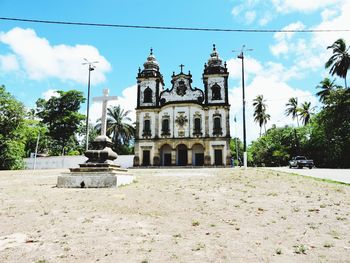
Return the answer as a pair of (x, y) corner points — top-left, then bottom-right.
(228, 55), (317, 142)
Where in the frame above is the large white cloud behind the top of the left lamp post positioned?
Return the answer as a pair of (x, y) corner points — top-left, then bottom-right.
(0, 27), (111, 84)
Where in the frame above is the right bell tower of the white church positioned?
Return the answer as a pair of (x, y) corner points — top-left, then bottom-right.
(203, 44), (229, 105)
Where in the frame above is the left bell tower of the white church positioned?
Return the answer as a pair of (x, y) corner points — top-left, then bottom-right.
(136, 48), (164, 109)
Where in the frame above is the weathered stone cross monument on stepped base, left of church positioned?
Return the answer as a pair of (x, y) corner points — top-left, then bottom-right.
(57, 89), (134, 188)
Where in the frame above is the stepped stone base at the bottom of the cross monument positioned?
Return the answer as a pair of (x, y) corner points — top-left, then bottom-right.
(57, 165), (134, 188)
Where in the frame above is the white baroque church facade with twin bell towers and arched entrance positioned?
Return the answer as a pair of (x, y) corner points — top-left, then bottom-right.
(134, 45), (231, 166)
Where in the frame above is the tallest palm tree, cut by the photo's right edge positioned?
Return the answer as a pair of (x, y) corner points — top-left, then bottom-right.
(325, 38), (350, 88)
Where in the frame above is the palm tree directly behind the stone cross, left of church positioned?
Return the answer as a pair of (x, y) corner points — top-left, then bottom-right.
(96, 105), (135, 152)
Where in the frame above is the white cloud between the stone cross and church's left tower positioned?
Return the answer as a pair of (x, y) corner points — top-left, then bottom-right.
(90, 85), (137, 124)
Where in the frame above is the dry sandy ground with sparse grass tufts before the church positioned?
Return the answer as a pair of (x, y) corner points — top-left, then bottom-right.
(0, 168), (350, 262)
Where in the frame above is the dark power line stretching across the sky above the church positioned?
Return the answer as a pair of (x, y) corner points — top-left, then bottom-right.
(0, 17), (350, 33)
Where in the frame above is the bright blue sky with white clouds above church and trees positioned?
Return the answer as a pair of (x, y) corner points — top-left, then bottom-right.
(0, 0), (350, 140)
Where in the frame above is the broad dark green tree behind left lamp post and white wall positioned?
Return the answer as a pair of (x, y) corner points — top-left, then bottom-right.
(36, 90), (85, 155)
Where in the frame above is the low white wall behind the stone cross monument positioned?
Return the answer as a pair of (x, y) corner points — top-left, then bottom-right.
(24, 155), (134, 170)
